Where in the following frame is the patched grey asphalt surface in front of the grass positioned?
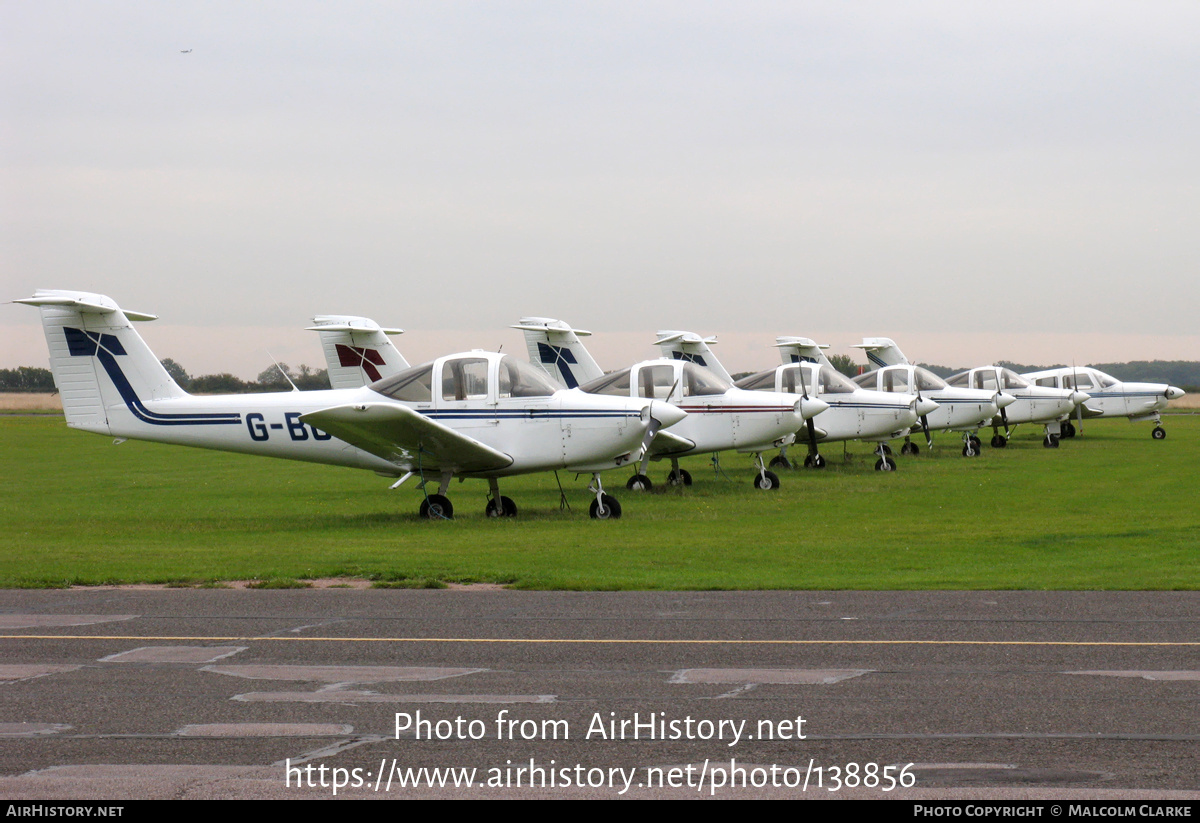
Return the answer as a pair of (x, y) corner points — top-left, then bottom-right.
(0, 589), (1200, 800)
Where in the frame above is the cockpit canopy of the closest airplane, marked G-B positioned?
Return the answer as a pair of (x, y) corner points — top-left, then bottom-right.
(371, 354), (562, 403)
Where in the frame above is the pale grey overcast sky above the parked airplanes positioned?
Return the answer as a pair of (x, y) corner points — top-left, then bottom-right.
(0, 0), (1200, 377)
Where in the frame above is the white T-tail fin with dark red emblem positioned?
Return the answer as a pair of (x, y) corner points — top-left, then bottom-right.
(308, 314), (408, 389)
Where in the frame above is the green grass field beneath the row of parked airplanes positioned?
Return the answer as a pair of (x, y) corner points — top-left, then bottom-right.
(0, 415), (1200, 589)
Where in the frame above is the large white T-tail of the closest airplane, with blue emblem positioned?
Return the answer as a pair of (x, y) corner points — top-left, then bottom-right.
(16, 289), (187, 434)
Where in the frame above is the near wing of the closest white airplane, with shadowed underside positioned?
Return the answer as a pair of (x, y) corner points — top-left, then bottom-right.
(300, 403), (512, 471)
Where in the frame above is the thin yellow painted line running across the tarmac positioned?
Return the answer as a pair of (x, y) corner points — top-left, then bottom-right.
(0, 635), (1200, 648)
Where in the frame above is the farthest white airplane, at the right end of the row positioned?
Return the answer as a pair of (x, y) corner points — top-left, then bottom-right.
(1021, 366), (1186, 440)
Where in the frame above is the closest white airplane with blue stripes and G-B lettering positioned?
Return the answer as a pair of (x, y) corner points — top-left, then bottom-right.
(17, 290), (686, 518)
